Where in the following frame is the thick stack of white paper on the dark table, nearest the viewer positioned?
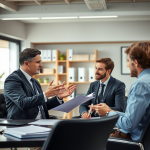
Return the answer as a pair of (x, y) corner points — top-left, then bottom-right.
(4, 125), (51, 138)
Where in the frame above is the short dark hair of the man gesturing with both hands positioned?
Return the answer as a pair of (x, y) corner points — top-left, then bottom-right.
(19, 48), (41, 66)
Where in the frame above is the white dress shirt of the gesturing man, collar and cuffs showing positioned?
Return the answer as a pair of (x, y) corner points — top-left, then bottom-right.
(20, 68), (63, 119)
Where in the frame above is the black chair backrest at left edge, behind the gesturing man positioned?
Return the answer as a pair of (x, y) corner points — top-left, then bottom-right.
(0, 93), (7, 118)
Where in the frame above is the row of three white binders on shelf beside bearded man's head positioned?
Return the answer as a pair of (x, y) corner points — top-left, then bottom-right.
(69, 67), (95, 82)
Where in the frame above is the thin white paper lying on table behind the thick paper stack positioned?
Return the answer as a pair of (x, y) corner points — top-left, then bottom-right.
(28, 119), (62, 126)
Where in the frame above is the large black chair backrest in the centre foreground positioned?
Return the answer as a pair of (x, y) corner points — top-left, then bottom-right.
(42, 115), (119, 150)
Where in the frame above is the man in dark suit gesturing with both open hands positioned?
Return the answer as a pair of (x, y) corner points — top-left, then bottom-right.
(4, 48), (76, 120)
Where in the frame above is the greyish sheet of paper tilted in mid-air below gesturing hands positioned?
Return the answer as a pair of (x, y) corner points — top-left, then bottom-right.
(51, 93), (94, 113)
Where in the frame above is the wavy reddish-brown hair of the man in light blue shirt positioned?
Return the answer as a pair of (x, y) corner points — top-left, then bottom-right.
(125, 42), (150, 69)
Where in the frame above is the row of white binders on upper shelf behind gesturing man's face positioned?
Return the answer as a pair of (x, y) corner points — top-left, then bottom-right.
(40, 50), (56, 61)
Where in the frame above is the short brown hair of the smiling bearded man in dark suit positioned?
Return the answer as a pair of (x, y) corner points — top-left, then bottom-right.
(96, 58), (114, 74)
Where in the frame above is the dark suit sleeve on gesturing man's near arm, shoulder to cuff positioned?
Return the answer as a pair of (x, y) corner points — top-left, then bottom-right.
(4, 77), (45, 111)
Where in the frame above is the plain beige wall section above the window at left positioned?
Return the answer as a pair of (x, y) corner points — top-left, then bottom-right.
(0, 20), (26, 40)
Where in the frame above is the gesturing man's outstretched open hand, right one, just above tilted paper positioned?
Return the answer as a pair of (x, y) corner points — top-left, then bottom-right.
(58, 82), (76, 99)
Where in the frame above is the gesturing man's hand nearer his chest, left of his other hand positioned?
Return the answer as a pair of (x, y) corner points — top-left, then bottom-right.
(45, 80), (65, 98)
